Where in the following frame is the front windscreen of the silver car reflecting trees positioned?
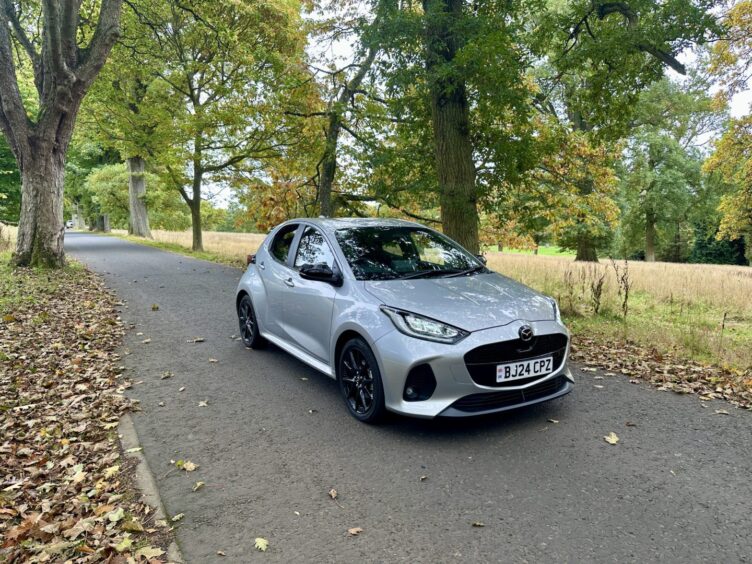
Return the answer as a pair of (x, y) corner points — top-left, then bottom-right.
(336, 226), (485, 280)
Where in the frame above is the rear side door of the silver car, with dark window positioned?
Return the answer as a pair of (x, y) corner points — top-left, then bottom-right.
(257, 223), (300, 340)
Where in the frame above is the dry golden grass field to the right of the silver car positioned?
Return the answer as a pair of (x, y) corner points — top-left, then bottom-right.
(487, 253), (752, 370)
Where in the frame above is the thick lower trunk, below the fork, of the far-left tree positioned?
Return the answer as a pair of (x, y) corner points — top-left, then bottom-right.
(13, 147), (65, 268)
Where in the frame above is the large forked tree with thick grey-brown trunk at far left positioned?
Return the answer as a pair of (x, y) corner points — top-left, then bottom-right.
(0, 0), (122, 267)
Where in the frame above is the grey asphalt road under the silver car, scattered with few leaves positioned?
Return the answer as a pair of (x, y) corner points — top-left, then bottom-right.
(66, 234), (752, 563)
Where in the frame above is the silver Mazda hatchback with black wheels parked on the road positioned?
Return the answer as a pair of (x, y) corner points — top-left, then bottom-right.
(236, 219), (574, 422)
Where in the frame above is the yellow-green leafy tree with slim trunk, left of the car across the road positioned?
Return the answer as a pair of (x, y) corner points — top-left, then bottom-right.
(94, 0), (306, 250)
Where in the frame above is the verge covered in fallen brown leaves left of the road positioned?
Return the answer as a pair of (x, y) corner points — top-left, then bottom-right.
(0, 252), (169, 562)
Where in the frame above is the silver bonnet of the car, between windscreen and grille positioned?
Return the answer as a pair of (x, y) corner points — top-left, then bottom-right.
(365, 273), (555, 331)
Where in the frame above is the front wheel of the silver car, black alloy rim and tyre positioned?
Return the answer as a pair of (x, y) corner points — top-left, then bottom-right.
(337, 338), (386, 423)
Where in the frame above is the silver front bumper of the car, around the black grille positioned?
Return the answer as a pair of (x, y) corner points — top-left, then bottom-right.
(374, 321), (574, 418)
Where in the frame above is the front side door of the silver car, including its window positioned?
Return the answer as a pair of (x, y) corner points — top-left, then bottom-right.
(284, 225), (338, 364)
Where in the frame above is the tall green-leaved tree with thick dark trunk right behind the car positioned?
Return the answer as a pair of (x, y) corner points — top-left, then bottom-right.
(368, 0), (716, 253)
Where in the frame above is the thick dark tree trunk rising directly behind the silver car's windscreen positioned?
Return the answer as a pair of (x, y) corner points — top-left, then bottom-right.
(423, 0), (480, 253)
